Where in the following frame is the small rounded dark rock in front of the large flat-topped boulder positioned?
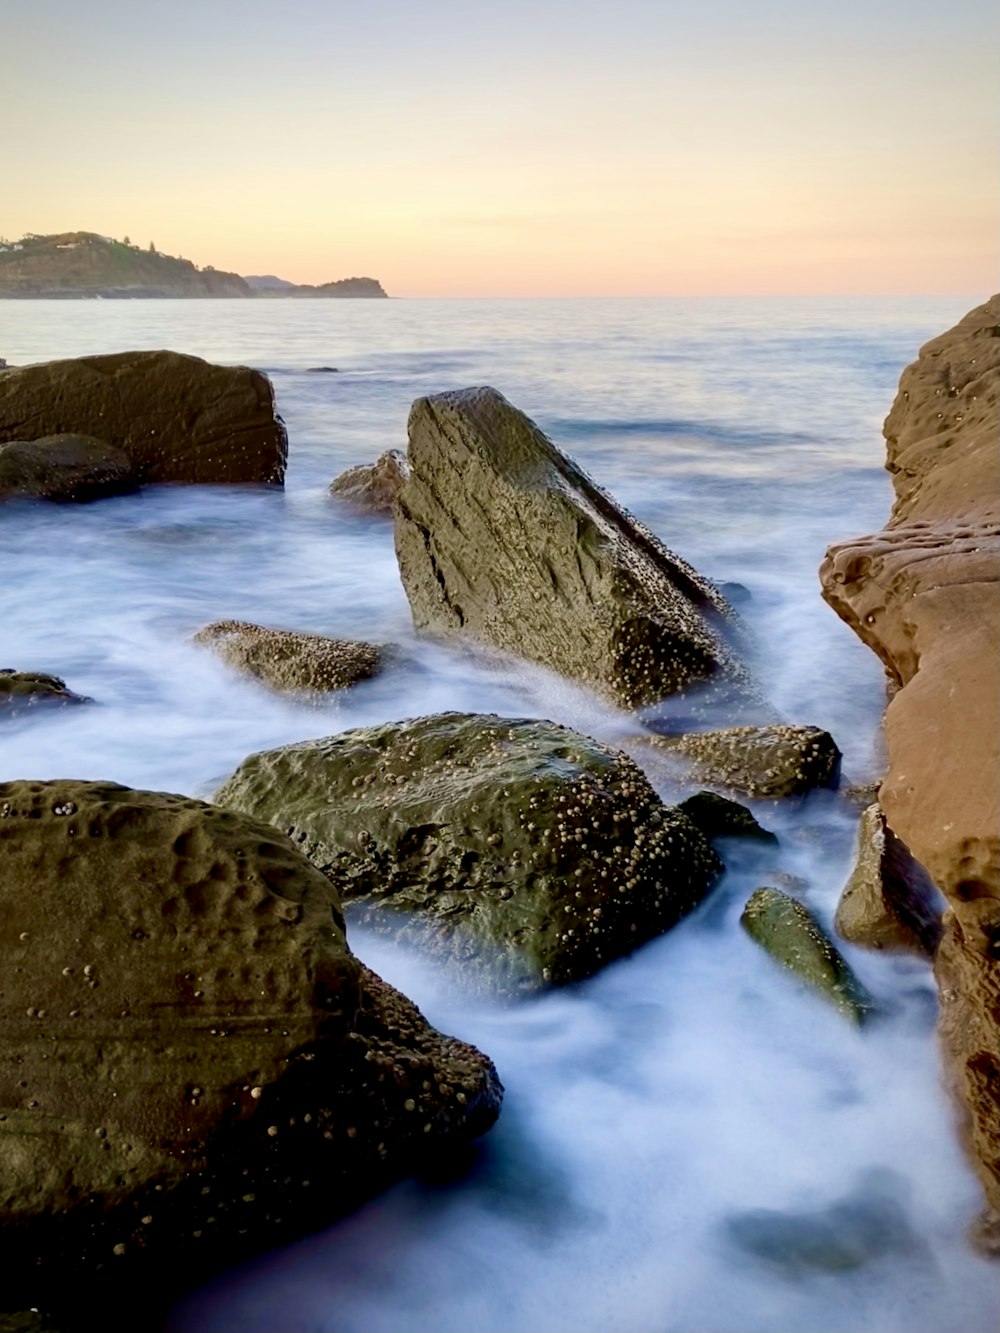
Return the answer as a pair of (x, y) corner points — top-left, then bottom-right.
(0, 435), (139, 503)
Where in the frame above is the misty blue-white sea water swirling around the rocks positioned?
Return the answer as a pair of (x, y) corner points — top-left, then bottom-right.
(0, 296), (1000, 1333)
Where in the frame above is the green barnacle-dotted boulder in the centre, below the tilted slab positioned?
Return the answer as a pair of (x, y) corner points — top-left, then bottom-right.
(216, 713), (721, 993)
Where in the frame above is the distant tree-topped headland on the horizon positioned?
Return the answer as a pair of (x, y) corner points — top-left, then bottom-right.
(0, 232), (388, 301)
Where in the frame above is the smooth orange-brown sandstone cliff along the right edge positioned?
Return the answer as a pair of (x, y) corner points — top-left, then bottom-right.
(820, 296), (1000, 1249)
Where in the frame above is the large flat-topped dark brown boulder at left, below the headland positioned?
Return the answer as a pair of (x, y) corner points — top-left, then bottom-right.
(0, 352), (288, 484)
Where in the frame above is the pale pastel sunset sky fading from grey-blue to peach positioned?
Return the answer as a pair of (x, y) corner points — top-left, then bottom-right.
(0, 0), (1000, 296)
